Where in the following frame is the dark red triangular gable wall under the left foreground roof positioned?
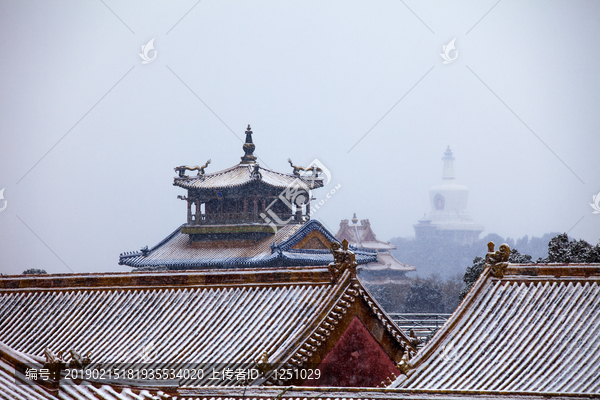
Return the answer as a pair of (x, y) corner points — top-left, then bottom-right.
(303, 317), (400, 387)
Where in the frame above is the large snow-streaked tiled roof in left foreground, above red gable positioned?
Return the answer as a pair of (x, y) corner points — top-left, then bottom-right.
(0, 267), (412, 390)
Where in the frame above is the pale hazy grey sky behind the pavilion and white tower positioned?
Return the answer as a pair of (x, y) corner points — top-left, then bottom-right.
(0, 0), (600, 273)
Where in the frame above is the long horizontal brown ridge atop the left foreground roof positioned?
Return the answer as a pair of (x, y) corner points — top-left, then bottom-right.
(0, 267), (331, 291)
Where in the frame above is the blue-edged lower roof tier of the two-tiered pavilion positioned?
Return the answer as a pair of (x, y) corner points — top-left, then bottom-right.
(119, 220), (376, 270)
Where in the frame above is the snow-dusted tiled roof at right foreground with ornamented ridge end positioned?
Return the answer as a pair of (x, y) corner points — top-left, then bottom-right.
(392, 244), (600, 397)
